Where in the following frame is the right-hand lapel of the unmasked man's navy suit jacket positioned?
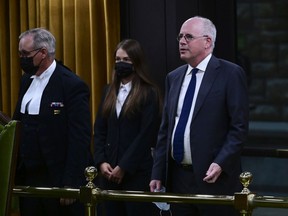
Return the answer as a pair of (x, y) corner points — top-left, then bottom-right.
(192, 56), (219, 122)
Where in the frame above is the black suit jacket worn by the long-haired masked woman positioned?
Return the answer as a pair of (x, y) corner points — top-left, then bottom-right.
(94, 86), (160, 190)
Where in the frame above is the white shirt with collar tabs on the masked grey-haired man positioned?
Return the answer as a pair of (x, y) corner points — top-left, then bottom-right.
(20, 60), (56, 115)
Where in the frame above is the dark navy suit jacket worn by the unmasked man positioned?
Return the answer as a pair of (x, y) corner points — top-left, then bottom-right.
(152, 56), (249, 194)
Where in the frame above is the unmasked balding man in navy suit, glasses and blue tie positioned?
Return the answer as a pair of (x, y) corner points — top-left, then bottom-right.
(150, 17), (249, 216)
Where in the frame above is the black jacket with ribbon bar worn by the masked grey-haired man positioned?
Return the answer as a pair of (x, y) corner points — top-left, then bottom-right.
(13, 63), (91, 187)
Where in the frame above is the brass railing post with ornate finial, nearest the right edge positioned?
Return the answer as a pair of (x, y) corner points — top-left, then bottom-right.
(234, 172), (255, 216)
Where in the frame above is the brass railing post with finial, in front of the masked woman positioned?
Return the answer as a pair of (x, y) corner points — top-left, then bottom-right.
(80, 166), (97, 216)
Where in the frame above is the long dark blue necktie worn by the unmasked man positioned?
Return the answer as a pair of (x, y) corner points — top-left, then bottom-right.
(173, 68), (198, 164)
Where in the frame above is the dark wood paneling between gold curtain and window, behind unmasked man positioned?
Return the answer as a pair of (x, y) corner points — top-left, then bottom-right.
(120, 0), (236, 93)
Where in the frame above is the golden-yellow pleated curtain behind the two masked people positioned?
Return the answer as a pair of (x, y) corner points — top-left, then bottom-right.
(0, 0), (120, 122)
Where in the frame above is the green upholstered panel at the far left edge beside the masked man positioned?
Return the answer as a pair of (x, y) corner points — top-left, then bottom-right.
(0, 121), (17, 215)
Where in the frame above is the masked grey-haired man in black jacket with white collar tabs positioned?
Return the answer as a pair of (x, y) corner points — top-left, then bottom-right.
(13, 28), (91, 216)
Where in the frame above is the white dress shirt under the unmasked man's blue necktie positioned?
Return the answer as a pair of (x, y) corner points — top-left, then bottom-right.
(171, 54), (212, 164)
